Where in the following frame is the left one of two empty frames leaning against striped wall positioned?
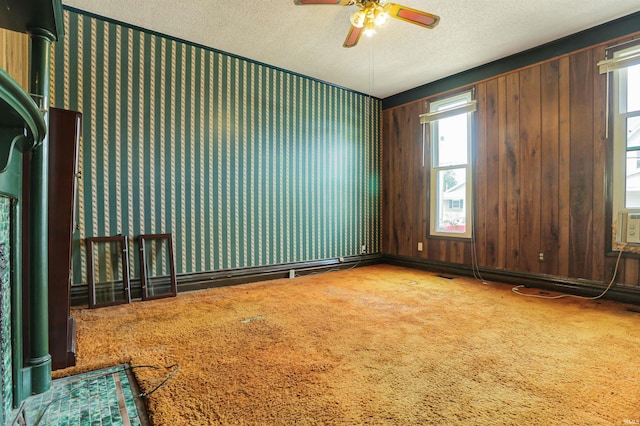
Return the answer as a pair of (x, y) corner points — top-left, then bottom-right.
(86, 235), (131, 308)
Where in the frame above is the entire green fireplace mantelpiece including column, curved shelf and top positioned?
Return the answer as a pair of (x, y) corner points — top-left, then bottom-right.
(0, 0), (64, 416)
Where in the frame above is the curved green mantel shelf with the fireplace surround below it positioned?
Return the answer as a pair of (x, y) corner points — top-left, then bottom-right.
(0, 65), (46, 424)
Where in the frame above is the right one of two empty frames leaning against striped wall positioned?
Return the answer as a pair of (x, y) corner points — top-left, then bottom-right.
(138, 234), (178, 300)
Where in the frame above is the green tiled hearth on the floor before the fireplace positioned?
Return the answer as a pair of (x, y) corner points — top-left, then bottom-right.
(25, 365), (145, 426)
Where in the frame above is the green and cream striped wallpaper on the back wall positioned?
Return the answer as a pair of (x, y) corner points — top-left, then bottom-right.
(50, 10), (381, 283)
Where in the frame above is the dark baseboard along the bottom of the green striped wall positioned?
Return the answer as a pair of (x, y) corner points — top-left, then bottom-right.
(71, 254), (382, 306)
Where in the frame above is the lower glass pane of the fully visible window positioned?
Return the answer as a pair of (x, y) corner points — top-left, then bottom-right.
(436, 168), (467, 234)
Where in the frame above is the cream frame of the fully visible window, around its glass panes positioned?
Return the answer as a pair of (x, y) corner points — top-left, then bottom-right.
(420, 88), (477, 240)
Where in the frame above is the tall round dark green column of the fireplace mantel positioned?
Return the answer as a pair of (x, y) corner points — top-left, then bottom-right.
(26, 28), (56, 394)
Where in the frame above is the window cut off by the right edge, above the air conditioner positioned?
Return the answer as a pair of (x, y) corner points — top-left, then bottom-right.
(599, 42), (640, 223)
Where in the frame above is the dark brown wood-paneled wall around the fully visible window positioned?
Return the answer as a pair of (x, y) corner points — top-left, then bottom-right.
(382, 33), (639, 286)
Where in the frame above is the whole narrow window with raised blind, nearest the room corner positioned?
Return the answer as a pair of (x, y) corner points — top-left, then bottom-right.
(421, 91), (476, 238)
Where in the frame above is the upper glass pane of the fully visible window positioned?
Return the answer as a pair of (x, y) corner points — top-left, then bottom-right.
(434, 113), (467, 167)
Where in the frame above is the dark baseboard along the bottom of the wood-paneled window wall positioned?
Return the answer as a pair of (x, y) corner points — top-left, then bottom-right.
(381, 254), (640, 305)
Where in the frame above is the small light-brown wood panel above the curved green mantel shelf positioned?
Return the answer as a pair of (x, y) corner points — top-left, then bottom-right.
(0, 28), (29, 91)
